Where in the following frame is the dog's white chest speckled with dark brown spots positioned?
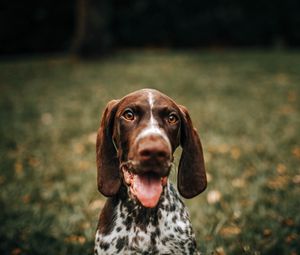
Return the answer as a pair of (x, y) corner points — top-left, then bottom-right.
(95, 185), (197, 254)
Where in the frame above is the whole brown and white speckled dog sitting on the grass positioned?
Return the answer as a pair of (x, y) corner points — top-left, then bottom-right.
(95, 89), (207, 254)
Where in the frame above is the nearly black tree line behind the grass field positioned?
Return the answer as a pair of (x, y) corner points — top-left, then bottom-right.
(0, 0), (300, 56)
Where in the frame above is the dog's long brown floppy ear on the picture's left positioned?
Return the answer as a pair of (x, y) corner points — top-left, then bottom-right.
(96, 100), (121, 197)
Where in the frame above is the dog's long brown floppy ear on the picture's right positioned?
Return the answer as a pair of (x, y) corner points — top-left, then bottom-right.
(177, 105), (207, 198)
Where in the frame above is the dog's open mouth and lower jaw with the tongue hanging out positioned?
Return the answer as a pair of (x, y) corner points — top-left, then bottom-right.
(122, 167), (168, 208)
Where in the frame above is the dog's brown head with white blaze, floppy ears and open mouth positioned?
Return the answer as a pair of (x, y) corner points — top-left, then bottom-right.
(96, 89), (206, 208)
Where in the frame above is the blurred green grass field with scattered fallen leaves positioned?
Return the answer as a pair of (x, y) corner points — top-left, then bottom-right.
(0, 50), (300, 255)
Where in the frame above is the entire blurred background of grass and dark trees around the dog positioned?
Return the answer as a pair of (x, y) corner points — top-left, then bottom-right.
(0, 0), (300, 255)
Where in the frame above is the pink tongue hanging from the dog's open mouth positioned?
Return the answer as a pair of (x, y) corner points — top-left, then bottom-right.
(133, 175), (162, 208)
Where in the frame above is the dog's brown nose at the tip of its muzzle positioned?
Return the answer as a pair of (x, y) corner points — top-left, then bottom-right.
(138, 136), (171, 163)
